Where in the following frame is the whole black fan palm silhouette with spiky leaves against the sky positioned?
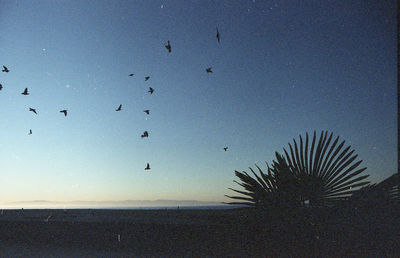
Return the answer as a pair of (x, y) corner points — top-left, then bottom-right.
(226, 131), (369, 208)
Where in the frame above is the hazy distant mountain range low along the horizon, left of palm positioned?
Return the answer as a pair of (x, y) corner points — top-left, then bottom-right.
(3, 200), (224, 207)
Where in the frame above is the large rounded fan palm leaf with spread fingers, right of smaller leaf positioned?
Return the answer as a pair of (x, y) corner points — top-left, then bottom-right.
(284, 131), (369, 205)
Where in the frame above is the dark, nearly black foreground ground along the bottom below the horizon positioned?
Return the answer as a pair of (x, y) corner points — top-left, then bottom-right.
(0, 206), (400, 257)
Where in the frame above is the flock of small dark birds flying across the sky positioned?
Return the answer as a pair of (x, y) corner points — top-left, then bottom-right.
(0, 28), (228, 170)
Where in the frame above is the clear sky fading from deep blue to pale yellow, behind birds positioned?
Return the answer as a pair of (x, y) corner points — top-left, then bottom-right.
(0, 0), (398, 205)
